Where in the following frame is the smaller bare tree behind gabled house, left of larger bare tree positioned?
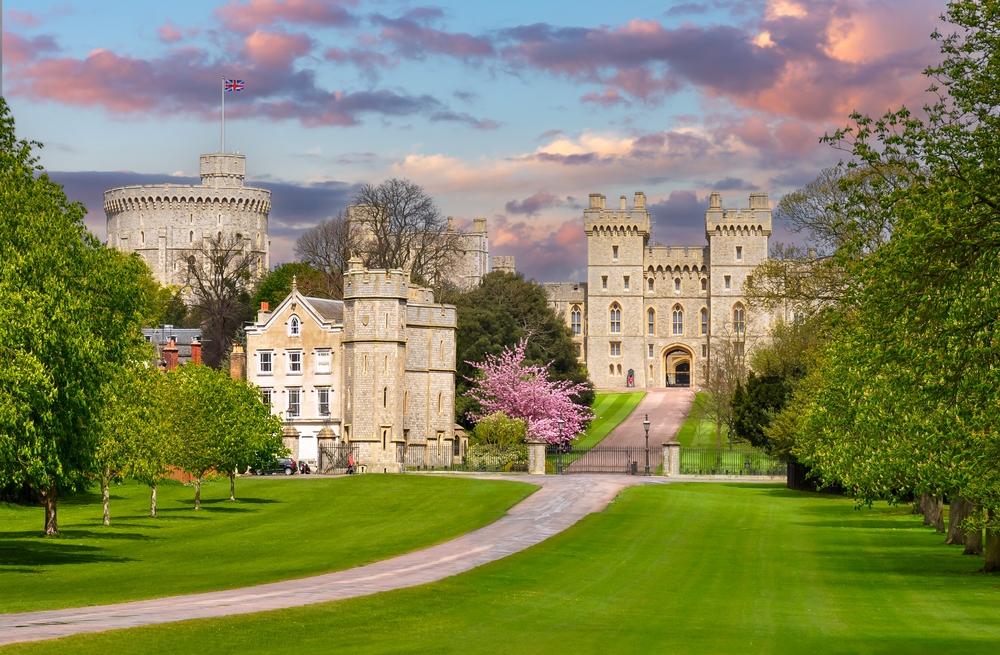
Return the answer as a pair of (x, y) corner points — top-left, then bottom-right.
(292, 211), (361, 300)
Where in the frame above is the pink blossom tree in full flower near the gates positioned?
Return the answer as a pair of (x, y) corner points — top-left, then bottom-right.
(466, 339), (594, 444)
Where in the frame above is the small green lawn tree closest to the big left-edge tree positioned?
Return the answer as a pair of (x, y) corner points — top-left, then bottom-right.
(94, 363), (164, 525)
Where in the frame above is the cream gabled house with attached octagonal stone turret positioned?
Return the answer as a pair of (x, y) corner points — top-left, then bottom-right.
(246, 259), (464, 472)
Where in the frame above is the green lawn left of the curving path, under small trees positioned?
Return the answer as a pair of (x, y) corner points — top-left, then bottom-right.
(0, 475), (536, 612)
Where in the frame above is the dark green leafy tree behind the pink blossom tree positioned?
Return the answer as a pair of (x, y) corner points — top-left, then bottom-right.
(442, 271), (594, 427)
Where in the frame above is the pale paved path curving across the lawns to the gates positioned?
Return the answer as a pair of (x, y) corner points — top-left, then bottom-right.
(0, 475), (666, 645)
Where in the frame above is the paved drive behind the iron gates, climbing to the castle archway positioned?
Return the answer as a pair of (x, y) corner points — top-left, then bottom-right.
(600, 387), (695, 450)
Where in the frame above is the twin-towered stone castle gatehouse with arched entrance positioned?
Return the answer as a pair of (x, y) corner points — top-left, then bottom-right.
(543, 192), (787, 388)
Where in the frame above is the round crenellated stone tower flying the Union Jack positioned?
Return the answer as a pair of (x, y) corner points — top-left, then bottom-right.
(104, 153), (271, 287)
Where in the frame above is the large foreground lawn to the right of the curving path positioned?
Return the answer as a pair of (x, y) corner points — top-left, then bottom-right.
(5, 483), (1000, 655)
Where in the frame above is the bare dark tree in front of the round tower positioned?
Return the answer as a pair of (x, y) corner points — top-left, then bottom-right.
(183, 232), (258, 368)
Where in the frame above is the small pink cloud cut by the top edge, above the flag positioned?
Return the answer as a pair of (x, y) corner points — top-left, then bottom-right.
(213, 0), (357, 32)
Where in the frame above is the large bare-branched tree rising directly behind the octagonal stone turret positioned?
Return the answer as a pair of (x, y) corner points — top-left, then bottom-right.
(352, 178), (461, 285)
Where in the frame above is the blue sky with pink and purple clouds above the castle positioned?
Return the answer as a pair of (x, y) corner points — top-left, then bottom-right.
(3, 0), (947, 281)
